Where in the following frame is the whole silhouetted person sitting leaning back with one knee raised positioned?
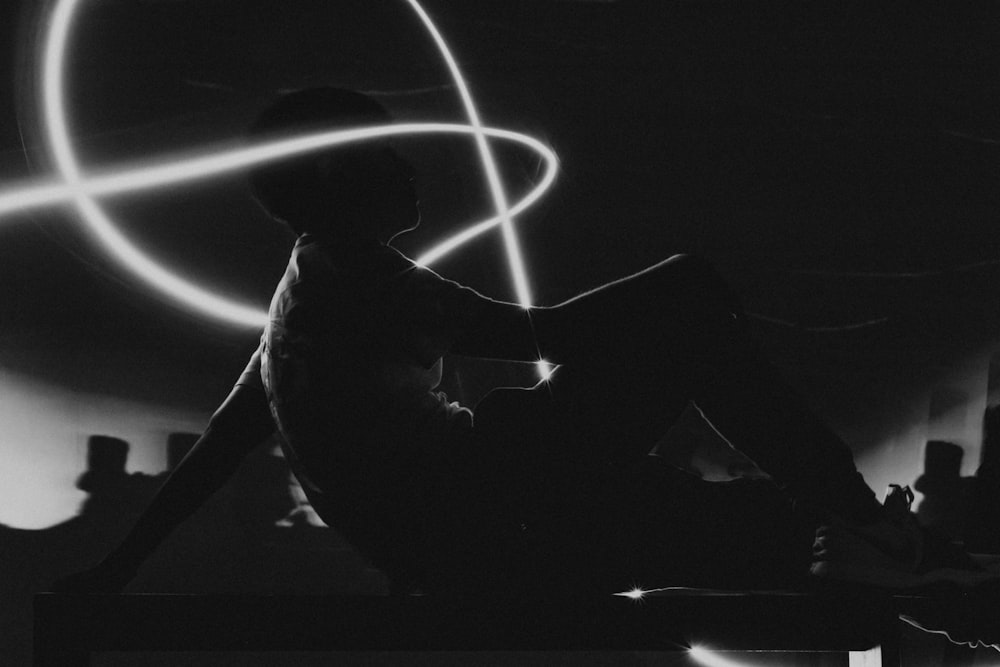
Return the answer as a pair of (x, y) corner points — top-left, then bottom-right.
(56, 89), (992, 593)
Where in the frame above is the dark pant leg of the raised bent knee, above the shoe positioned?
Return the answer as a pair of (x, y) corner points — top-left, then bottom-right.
(534, 256), (881, 521)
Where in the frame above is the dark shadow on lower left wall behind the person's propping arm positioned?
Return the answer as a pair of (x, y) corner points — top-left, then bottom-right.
(0, 433), (387, 665)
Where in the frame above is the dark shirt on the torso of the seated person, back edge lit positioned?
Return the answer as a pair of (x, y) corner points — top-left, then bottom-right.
(251, 235), (489, 584)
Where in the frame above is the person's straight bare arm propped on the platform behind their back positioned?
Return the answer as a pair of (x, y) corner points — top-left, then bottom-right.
(53, 364), (275, 593)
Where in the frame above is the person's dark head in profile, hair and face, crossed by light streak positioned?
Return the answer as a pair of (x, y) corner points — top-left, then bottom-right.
(249, 88), (420, 243)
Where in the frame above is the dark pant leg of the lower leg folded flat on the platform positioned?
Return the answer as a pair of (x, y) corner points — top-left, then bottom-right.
(464, 391), (815, 593)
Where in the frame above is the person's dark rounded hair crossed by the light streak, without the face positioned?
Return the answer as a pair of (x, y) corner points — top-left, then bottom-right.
(247, 88), (394, 234)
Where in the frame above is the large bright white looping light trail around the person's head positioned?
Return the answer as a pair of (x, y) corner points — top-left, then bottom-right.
(0, 0), (558, 344)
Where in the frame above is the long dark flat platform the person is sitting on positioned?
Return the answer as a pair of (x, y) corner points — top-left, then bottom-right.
(34, 589), (900, 667)
